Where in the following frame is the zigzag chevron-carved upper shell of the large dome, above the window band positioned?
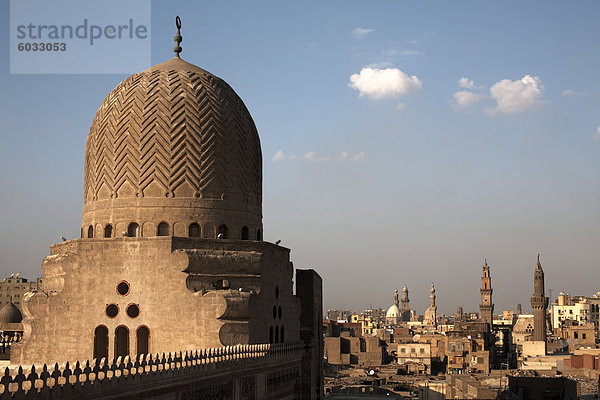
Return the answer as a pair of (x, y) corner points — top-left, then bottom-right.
(84, 58), (262, 206)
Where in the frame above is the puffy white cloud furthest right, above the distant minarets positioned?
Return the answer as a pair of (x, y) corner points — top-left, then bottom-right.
(488, 75), (544, 115)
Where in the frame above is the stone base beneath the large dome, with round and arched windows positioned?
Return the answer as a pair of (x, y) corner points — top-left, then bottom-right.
(11, 237), (304, 364)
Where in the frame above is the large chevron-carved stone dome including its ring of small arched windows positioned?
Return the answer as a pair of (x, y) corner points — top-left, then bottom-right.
(82, 57), (262, 240)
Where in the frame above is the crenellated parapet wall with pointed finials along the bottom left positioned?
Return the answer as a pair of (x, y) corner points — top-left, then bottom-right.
(0, 344), (303, 400)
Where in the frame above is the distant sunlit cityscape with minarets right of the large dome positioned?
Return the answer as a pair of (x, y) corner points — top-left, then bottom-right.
(327, 256), (600, 388)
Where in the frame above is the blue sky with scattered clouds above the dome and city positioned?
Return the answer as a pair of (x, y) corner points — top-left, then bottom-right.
(0, 0), (600, 313)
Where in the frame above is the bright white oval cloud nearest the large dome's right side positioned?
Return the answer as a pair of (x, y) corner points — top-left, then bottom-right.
(348, 67), (423, 99)
